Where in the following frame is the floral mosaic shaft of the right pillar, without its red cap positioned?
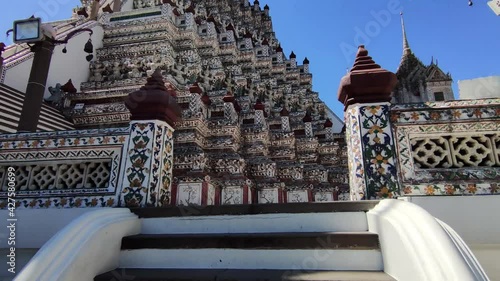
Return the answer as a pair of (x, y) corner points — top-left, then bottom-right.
(346, 103), (399, 200)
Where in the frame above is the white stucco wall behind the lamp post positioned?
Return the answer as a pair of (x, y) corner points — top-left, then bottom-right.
(4, 26), (104, 97)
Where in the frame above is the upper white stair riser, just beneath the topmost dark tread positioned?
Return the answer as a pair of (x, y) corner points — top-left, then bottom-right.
(141, 211), (368, 234)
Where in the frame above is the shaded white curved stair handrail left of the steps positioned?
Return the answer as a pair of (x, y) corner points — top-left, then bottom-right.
(14, 208), (141, 281)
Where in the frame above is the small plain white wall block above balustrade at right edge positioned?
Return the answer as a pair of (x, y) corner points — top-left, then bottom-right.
(458, 76), (500, 100)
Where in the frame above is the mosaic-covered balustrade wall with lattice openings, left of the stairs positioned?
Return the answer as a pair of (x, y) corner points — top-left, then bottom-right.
(0, 128), (128, 209)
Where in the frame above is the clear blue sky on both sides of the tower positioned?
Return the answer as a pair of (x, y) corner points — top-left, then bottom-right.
(0, 0), (500, 118)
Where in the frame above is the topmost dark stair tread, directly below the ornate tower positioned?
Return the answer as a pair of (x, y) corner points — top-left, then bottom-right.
(131, 200), (379, 218)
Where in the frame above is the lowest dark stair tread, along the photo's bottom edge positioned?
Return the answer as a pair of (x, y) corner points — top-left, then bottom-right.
(94, 268), (395, 281)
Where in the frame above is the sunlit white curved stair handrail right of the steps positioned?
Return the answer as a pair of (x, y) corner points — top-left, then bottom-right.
(367, 199), (489, 281)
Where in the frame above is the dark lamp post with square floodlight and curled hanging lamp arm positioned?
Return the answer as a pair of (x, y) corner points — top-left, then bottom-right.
(7, 17), (94, 132)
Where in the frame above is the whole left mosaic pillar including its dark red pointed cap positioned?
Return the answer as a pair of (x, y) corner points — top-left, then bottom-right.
(120, 70), (181, 207)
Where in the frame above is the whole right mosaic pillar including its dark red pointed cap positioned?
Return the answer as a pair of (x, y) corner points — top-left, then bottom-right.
(338, 46), (399, 200)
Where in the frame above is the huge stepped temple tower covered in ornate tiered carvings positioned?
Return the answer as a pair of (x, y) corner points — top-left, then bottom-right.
(48, 0), (349, 202)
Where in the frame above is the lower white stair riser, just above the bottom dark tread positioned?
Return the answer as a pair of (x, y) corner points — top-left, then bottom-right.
(119, 248), (384, 271)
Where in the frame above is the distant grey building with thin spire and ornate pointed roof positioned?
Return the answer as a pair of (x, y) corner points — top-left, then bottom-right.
(392, 13), (454, 103)
